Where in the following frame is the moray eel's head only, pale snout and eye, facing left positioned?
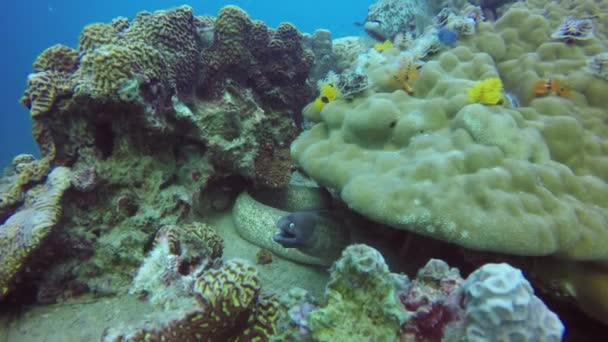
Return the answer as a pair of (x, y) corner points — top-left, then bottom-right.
(272, 211), (317, 248)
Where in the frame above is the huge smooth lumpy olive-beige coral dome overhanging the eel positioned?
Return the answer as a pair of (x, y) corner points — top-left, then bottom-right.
(291, 5), (608, 260)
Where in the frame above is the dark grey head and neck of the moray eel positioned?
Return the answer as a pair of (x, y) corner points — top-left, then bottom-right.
(272, 211), (350, 260)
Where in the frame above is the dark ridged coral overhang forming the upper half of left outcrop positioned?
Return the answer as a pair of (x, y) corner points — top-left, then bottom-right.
(21, 6), (308, 187)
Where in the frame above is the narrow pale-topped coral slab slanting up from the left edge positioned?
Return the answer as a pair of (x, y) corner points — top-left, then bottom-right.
(0, 167), (70, 300)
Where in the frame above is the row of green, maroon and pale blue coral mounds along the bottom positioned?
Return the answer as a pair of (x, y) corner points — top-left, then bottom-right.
(275, 244), (564, 341)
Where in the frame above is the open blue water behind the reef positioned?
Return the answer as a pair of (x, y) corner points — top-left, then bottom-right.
(0, 0), (373, 170)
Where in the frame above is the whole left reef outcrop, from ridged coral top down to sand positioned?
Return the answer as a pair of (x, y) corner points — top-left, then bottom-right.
(8, 6), (314, 301)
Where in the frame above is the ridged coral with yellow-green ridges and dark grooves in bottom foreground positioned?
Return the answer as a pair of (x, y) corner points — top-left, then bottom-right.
(104, 260), (279, 341)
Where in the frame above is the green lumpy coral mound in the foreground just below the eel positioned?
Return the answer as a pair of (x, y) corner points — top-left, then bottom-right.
(308, 245), (407, 341)
